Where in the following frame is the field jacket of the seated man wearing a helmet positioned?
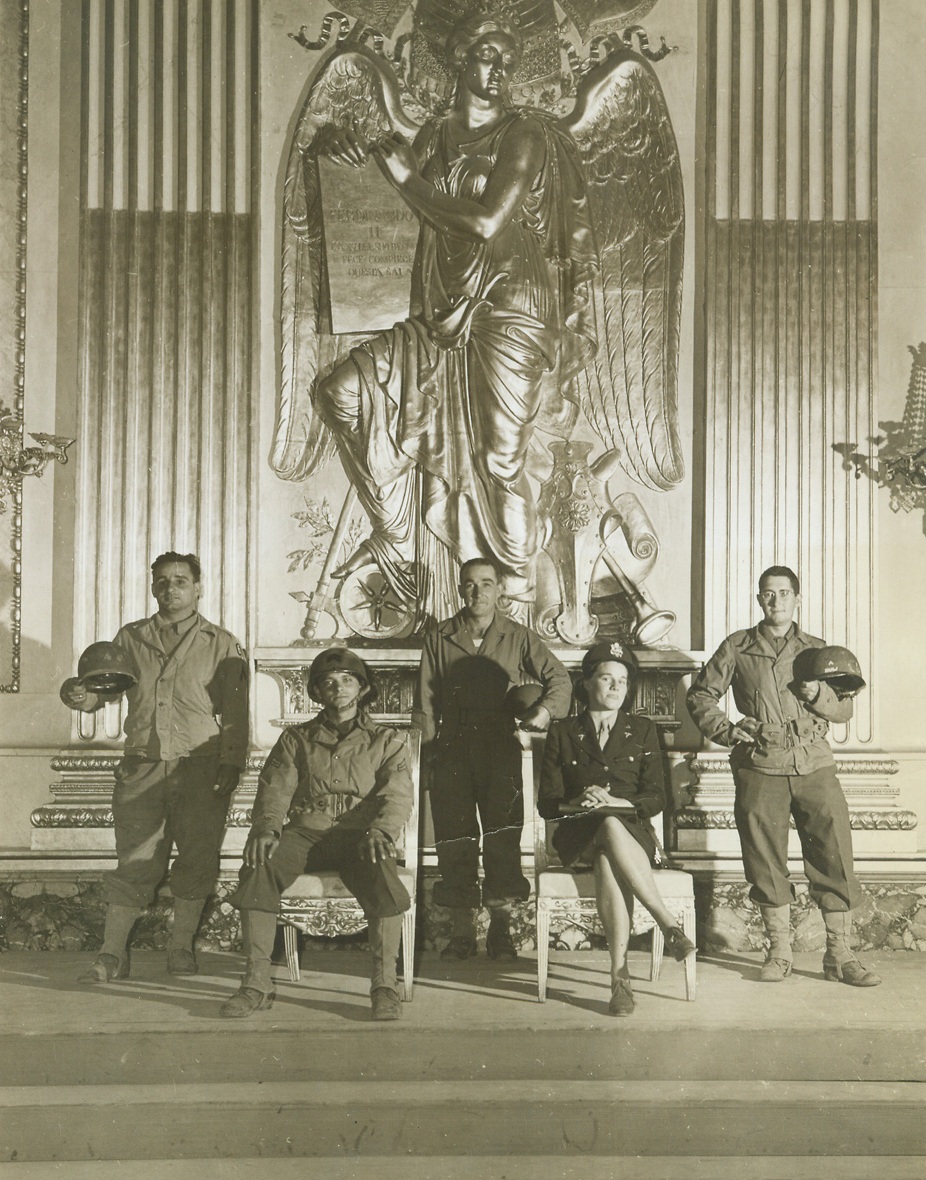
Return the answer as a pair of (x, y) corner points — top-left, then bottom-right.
(251, 713), (413, 843)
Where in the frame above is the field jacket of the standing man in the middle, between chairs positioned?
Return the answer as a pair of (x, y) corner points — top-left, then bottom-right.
(412, 611), (572, 742)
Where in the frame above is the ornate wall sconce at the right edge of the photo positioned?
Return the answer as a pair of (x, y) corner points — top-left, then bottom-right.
(836, 342), (926, 530)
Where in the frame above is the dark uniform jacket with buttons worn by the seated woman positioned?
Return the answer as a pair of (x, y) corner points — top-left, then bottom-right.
(538, 710), (665, 820)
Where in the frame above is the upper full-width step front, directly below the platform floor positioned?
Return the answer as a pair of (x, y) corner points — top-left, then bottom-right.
(0, 1024), (926, 1087)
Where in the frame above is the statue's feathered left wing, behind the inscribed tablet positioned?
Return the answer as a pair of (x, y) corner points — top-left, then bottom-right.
(270, 45), (419, 479)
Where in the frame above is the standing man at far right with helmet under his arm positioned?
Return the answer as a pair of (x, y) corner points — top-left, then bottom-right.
(688, 565), (881, 988)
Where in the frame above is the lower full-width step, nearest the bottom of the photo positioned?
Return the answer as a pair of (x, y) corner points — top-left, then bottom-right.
(0, 1081), (926, 1174)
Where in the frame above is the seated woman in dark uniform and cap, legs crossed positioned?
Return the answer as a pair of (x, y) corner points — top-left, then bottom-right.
(539, 643), (695, 1016)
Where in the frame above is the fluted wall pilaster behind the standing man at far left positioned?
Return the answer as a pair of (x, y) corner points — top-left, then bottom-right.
(74, 0), (257, 736)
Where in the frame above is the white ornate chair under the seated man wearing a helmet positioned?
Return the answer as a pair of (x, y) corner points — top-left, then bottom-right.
(278, 728), (421, 1001)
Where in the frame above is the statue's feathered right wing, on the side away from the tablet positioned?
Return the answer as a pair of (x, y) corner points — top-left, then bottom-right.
(564, 50), (684, 490)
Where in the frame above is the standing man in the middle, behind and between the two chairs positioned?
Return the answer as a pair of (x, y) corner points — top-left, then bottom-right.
(413, 557), (572, 959)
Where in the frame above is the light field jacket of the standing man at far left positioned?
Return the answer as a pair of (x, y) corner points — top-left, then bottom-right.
(100, 614), (248, 769)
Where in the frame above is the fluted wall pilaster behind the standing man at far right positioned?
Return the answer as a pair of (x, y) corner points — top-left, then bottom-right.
(703, 0), (878, 746)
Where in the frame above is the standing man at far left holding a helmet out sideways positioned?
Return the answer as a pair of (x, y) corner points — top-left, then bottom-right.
(61, 551), (248, 983)
